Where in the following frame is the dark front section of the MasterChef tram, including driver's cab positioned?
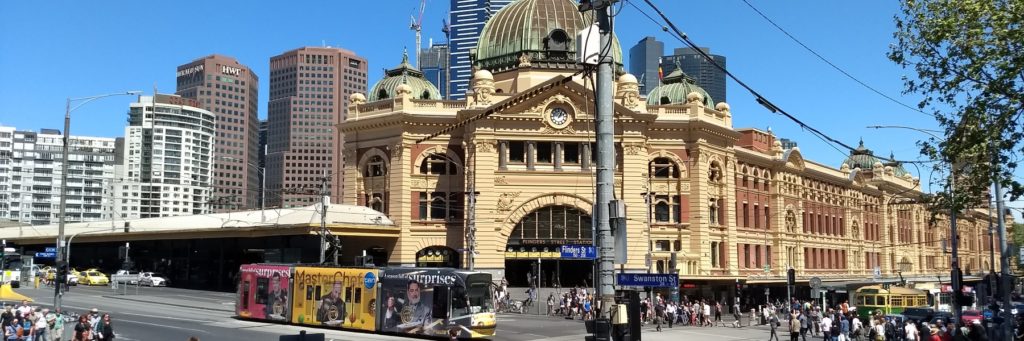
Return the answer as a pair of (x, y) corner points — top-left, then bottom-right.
(379, 267), (496, 338)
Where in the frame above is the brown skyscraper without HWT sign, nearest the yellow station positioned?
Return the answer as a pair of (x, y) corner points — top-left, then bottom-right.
(265, 47), (367, 207)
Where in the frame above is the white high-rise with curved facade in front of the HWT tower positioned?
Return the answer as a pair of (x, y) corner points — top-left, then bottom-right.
(112, 94), (216, 218)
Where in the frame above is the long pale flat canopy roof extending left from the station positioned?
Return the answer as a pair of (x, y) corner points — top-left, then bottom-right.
(0, 204), (399, 244)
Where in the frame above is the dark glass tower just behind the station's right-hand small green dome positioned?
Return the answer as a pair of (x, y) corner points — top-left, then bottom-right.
(659, 47), (728, 103)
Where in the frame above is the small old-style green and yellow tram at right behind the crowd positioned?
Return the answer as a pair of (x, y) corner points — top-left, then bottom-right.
(856, 286), (928, 318)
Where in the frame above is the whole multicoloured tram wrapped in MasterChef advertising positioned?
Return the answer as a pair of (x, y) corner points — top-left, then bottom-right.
(236, 264), (497, 338)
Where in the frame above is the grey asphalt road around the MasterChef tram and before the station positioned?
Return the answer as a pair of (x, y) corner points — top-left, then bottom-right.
(9, 286), (768, 341)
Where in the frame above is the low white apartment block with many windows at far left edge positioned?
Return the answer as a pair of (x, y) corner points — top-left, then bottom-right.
(0, 127), (115, 225)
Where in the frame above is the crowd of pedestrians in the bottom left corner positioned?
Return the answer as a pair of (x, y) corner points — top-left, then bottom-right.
(0, 301), (115, 341)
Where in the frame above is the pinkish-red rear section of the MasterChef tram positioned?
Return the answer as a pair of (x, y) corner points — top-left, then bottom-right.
(238, 264), (292, 322)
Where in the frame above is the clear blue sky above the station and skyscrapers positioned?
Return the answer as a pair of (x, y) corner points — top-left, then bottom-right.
(0, 0), (1024, 215)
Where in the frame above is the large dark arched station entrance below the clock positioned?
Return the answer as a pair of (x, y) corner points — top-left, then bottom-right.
(505, 205), (594, 287)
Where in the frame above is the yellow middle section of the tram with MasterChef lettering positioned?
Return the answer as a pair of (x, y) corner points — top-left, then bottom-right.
(292, 266), (378, 331)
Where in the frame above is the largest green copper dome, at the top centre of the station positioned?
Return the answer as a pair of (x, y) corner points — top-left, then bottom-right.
(474, 0), (623, 72)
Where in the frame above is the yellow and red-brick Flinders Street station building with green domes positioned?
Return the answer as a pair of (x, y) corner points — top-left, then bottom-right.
(339, 0), (998, 298)
